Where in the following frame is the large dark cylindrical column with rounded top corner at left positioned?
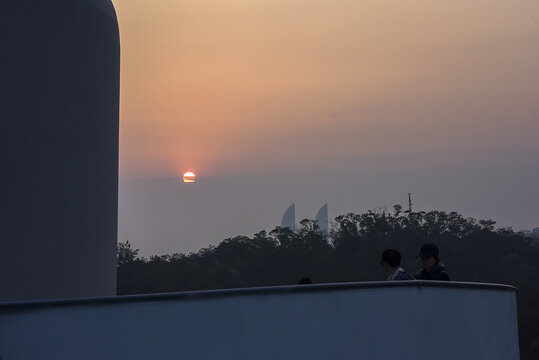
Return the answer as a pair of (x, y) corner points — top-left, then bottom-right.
(0, 0), (120, 300)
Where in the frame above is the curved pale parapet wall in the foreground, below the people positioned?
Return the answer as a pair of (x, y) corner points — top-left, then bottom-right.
(0, 283), (519, 360)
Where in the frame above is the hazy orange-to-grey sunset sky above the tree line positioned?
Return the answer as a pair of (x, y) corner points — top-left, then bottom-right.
(113, 0), (539, 255)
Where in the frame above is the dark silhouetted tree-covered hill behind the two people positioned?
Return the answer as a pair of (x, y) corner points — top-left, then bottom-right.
(118, 205), (539, 360)
